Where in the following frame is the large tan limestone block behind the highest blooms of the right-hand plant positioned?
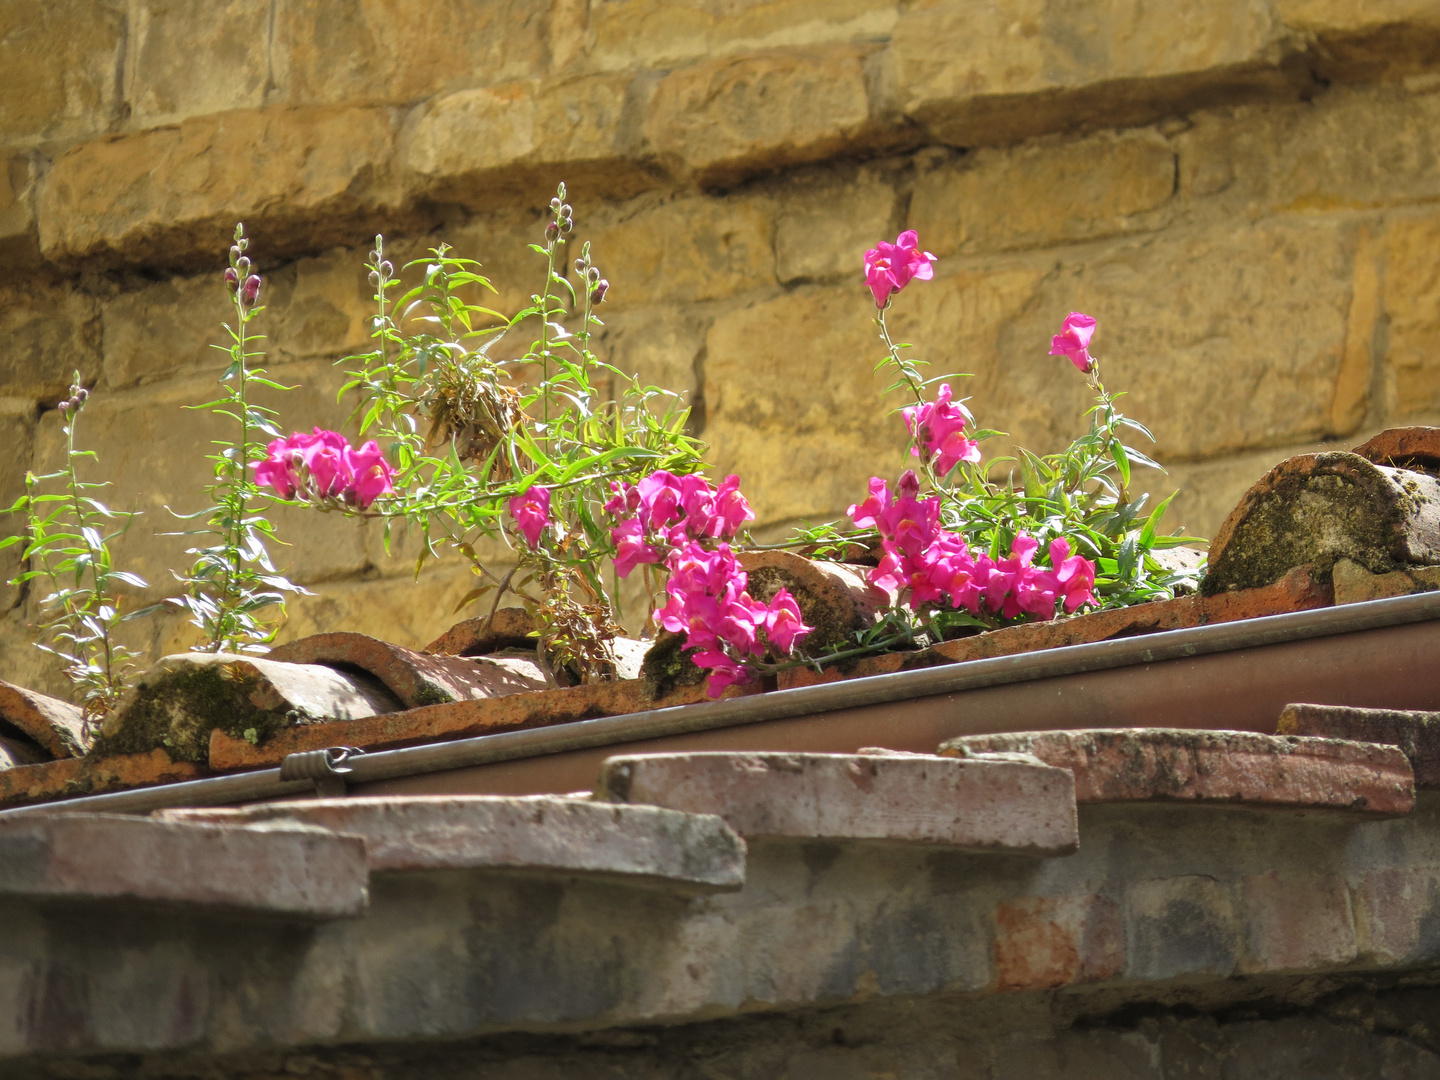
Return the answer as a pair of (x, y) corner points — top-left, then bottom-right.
(944, 220), (1356, 463)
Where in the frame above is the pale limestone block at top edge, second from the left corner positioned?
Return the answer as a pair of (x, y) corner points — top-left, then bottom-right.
(125, 0), (272, 128)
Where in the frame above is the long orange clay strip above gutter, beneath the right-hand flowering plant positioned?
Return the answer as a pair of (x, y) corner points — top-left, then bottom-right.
(779, 566), (1331, 690)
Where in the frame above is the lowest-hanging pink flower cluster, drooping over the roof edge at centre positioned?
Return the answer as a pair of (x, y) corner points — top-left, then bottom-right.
(655, 541), (814, 697)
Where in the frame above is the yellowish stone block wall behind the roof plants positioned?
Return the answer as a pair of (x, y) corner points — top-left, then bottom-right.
(0, 0), (1440, 685)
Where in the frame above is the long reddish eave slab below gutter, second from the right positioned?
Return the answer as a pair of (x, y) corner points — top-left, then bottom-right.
(940, 727), (1416, 814)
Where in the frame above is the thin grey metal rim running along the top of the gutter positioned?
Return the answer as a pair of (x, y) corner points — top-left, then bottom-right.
(11, 592), (1440, 821)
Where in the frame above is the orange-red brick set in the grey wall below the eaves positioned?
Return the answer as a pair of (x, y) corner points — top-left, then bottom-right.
(995, 894), (1125, 991)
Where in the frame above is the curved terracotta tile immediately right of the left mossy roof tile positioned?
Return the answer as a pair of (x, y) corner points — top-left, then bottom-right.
(265, 632), (546, 708)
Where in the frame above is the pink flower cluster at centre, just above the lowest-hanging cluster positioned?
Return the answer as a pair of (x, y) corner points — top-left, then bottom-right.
(605, 469), (755, 577)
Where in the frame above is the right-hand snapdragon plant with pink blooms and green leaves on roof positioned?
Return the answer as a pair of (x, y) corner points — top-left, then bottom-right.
(796, 232), (1198, 665)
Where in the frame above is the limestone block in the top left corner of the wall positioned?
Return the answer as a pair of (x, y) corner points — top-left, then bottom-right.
(0, 0), (127, 144)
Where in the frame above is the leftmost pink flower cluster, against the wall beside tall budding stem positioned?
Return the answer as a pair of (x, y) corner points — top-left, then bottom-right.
(251, 428), (395, 510)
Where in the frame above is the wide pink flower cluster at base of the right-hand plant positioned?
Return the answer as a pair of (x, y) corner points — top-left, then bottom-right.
(850, 471), (1094, 619)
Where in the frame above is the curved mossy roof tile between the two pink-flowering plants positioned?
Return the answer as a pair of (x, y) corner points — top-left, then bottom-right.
(739, 552), (893, 652)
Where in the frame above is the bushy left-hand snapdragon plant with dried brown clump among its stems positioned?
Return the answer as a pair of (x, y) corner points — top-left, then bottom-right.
(322, 184), (708, 683)
